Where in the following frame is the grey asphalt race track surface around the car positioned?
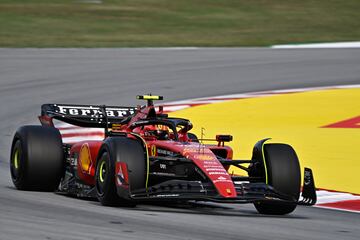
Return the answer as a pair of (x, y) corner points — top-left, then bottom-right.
(0, 48), (360, 240)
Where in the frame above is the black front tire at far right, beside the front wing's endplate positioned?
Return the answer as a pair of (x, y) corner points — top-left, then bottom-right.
(254, 143), (301, 215)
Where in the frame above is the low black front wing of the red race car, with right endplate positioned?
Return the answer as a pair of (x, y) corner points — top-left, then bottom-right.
(130, 169), (316, 205)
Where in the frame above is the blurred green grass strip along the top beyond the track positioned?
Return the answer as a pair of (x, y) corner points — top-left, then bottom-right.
(0, 0), (360, 47)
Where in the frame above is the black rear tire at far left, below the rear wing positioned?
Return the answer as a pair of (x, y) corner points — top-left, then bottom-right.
(10, 126), (65, 191)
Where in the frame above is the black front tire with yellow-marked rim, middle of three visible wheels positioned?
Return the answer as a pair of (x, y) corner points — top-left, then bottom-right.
(95, 137), (147, 207)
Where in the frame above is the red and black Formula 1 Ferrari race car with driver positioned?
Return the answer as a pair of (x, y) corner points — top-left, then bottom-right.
(10, 95), (316, 214)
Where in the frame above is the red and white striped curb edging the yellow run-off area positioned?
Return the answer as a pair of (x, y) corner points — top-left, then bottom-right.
(55, 84), (360, 213)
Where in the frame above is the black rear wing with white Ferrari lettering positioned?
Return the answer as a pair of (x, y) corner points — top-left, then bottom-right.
(39, 104), (136, 128)
